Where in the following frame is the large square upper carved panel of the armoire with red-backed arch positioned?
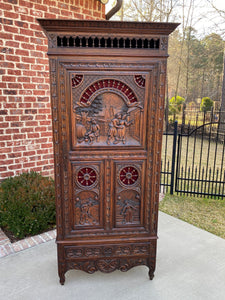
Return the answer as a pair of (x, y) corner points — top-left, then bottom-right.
(70, 72), (149, 149)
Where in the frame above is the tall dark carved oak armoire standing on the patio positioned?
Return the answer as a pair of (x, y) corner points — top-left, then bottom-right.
(39, 19), (178, 284)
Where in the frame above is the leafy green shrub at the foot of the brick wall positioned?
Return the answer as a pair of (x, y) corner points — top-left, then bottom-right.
(0, 172), (55, 238)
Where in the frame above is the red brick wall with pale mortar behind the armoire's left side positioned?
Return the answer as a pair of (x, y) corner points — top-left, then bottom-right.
(0, 0), (105, 180)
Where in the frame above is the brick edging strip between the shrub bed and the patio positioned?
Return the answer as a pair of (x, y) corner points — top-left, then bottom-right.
(0, 228), (56, 258)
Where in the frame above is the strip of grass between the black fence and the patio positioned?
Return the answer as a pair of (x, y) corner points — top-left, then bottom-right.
(159, 194), (225, 239)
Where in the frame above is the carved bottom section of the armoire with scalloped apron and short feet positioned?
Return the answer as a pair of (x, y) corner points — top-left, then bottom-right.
(57, 240), (156, 285)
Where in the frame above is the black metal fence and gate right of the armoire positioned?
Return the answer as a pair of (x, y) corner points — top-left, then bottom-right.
(161, 111), (225, 198)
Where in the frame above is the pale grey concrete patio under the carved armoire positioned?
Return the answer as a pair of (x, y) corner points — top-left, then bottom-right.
(0, 213), (225, 300)
